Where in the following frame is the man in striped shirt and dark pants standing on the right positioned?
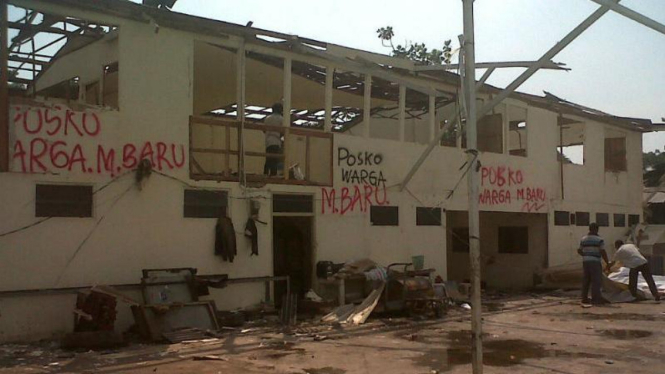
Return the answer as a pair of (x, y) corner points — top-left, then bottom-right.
(577, 222), (608, 304)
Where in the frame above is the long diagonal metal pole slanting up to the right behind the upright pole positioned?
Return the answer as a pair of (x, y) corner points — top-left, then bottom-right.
(400, 0), (615, 190)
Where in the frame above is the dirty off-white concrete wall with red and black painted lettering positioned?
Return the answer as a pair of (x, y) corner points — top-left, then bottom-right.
(0, 0), (641, 341)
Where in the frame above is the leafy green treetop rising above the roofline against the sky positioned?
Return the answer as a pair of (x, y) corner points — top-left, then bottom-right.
(376, 26), (452, 65)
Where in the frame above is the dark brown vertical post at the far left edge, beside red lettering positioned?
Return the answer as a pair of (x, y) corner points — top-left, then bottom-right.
(0, 0), (9, 172)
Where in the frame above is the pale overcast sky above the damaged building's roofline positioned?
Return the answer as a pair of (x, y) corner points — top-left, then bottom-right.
(154, 0), (665, 151)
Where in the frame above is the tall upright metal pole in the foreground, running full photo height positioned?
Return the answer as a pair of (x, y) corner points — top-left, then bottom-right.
(462, 0), (483, 374)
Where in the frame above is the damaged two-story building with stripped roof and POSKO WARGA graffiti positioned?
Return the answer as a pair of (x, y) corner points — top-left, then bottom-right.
(0, 0), (655, 341)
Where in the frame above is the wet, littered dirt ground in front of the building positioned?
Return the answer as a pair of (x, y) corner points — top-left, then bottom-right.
(0, 295), (665, 374)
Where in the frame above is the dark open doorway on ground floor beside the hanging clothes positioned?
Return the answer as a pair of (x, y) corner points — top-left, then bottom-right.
(273, 216), (313, 305)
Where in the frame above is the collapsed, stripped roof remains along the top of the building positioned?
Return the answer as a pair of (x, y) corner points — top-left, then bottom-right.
(3, 0), (665, 132)
